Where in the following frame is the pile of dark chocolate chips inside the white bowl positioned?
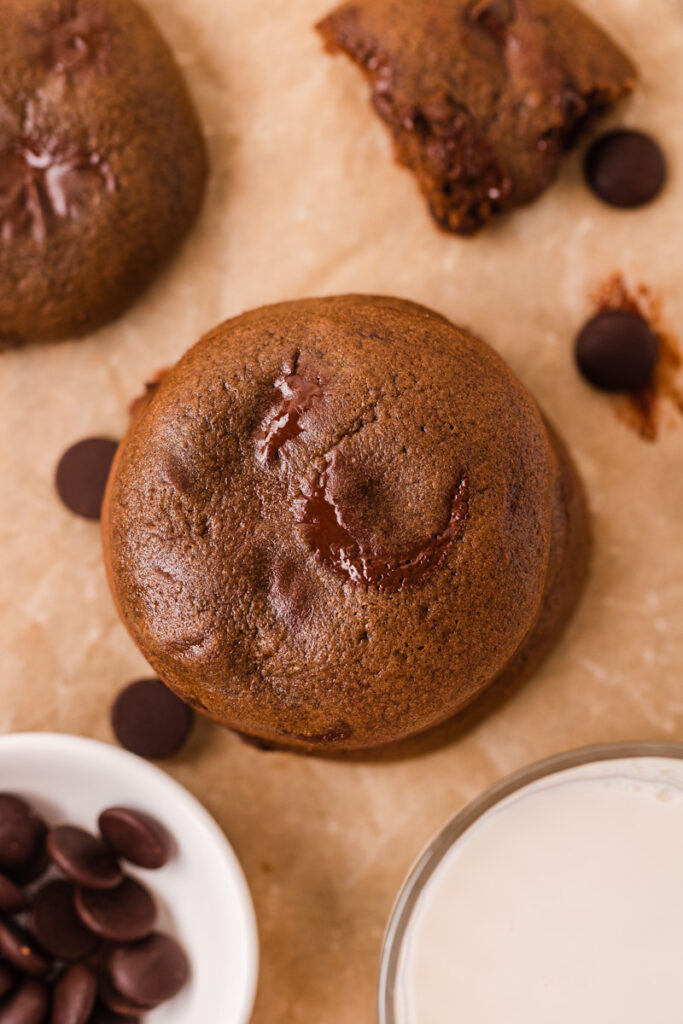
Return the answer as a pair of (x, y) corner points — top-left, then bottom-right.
(0, 794), (189, 1024)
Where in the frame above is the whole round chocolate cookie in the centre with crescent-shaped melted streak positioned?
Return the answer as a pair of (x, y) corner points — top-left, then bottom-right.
(103, 296), (587, 751)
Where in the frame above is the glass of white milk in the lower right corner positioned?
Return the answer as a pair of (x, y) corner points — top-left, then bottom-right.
(379, 743), (683, 1024)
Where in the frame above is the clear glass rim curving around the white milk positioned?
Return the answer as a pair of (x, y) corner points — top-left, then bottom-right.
(379, 742), (683, 1024)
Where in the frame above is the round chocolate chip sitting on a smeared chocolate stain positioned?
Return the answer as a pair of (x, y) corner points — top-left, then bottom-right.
(577, 309), (658, 392)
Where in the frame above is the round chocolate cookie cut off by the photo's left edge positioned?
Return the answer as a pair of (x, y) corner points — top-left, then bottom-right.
(0, 0), (207, 349)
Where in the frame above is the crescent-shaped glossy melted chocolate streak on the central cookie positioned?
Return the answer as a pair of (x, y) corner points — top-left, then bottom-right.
(299, 470), (469, 594)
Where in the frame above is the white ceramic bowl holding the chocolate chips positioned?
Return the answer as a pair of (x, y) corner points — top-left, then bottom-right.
(0, 733), (258, 1024)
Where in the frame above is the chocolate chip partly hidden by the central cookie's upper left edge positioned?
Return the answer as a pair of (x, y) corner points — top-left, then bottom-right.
(55, 437), (118, 519)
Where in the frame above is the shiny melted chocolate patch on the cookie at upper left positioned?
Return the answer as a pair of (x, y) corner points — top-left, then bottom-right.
(0, 137), (116, 244)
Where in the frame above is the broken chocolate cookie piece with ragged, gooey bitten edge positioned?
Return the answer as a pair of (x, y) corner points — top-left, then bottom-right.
(317, 0), (636, 234)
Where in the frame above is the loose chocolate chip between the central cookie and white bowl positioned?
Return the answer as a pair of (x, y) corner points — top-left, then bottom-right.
(112, 679), (195, 761)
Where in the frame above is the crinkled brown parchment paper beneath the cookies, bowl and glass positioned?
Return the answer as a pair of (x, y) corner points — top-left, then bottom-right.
(0, 0), (683, 1024)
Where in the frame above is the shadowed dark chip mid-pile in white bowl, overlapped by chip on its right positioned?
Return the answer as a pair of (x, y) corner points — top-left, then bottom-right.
(31, 880), (97, 961)
